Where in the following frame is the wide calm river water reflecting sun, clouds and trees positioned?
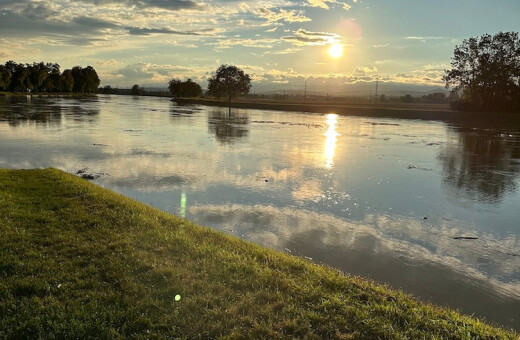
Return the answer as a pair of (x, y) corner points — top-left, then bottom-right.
(0, 96), (520, 330)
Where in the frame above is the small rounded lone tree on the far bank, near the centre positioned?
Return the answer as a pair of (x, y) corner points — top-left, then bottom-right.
(208, 65), (251, 101)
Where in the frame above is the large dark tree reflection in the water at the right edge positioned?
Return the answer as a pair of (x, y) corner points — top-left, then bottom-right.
(438, 124), (520, 203)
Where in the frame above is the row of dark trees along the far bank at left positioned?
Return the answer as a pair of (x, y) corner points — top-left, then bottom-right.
(0, 60), (100, 93)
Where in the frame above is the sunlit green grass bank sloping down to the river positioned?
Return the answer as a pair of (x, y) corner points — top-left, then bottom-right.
(0, 169), (517, 339)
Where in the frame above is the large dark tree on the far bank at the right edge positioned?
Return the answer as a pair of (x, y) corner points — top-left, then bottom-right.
(443, 32), (520, 111)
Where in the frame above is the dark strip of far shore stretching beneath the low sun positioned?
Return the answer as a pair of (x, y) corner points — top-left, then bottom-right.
(172, 98), (519, 122)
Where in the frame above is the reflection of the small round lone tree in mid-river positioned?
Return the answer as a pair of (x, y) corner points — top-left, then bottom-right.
(208, 108), (249, 144)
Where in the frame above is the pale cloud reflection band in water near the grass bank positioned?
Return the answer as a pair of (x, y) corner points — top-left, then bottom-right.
(189, 205), (520, 299)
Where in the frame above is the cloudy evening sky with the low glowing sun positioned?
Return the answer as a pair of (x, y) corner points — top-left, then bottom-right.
(0, 0), (520, 94)
